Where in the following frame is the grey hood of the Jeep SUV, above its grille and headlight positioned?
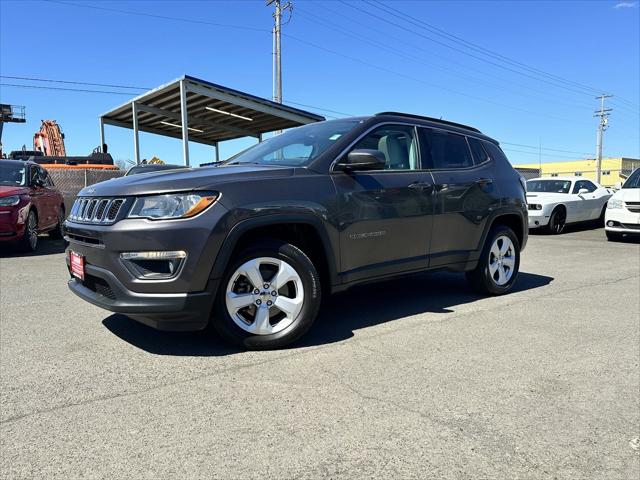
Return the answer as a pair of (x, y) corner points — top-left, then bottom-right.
(78, 165), (294, 197)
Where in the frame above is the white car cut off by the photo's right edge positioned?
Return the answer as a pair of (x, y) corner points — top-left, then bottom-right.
(604, 168), (640, 244)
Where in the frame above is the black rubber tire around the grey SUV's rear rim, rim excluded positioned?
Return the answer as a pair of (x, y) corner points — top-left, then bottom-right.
(466, 225), (520, 295)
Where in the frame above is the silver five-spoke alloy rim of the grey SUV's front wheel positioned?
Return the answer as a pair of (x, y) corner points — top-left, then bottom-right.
(225, 257), (304, 335)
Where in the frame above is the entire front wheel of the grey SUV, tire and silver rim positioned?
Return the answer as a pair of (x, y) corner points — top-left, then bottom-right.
(211, 241), (320, 350)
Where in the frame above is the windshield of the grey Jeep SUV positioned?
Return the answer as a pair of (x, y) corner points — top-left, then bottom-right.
(225, 120), (359, 167)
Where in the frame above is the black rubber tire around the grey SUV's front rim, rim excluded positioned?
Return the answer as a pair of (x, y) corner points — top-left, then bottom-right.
(210, 240), (321, 350)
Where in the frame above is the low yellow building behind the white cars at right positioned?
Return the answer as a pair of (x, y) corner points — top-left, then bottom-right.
(514, 157), (640, 187)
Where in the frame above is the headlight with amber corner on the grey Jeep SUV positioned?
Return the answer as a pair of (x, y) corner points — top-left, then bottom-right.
(127, 192), (218, 220)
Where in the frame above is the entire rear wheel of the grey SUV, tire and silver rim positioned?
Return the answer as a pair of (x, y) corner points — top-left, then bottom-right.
(467, 225), (520, 295)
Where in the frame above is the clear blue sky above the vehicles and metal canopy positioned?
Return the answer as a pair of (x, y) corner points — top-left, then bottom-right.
(0, 0), (640, 167)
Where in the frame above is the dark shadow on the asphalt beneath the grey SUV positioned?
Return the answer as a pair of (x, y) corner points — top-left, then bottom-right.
(102, 272), (553, 356)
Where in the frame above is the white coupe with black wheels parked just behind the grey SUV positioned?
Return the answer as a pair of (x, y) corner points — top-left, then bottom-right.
(527, 177), (613, 234)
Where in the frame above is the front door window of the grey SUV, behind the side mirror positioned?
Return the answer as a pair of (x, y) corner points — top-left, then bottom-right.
(353, 125), (418, 170)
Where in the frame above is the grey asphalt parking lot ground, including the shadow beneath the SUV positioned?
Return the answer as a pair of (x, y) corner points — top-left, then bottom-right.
(0, 228), (640, 479)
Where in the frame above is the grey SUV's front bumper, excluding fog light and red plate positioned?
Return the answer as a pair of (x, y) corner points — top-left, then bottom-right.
(64, 204), (227, 331)
